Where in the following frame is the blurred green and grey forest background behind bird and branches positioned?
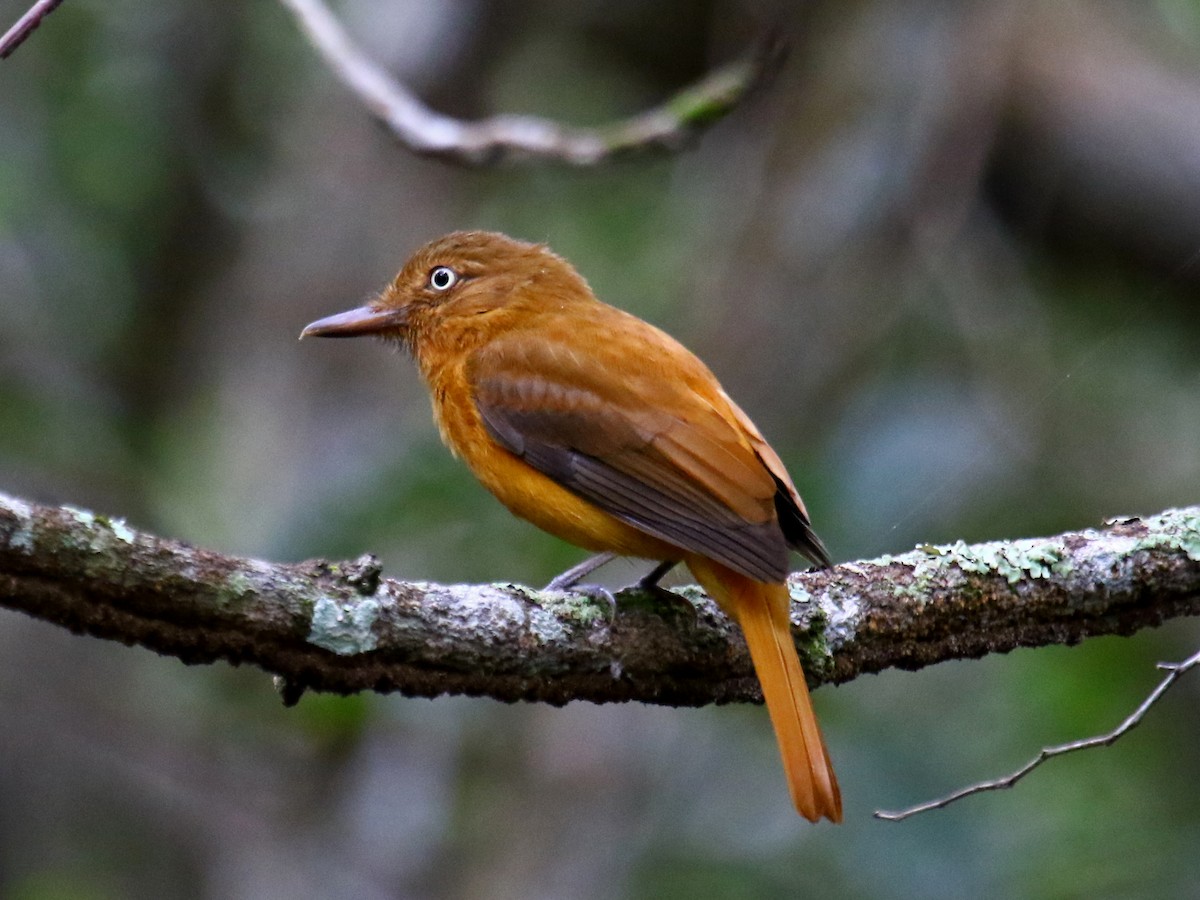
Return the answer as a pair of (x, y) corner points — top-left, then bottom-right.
(0, 0), (1200, 900)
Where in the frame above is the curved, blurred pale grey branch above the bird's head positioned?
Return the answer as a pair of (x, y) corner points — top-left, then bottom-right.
(282, 0), (782, 166)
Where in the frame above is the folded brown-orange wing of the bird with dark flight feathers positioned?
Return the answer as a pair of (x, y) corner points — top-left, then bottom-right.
(468, 317), (790, 582)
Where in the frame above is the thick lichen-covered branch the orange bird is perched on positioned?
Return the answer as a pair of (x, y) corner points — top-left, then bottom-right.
(0, 494), (1200, 706)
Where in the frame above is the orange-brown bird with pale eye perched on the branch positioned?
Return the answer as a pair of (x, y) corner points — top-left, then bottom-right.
(300, 230), (842, 822)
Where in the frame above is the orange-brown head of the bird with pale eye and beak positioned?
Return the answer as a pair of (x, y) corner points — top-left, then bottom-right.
(300, 232), (585, 350)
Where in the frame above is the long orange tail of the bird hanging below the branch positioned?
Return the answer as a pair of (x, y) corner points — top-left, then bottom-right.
(688, 557), (841, 822)
